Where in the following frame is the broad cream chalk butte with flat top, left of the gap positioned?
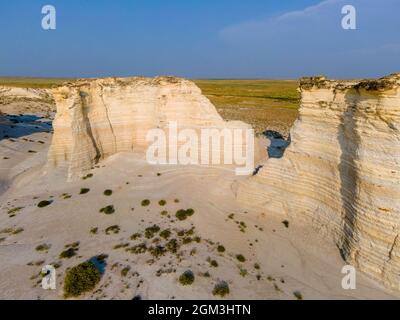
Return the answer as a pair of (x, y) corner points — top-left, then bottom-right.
(49, 77), (260, 179)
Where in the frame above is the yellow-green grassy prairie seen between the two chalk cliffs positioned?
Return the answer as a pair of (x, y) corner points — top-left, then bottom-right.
(195, 80), (300, 136)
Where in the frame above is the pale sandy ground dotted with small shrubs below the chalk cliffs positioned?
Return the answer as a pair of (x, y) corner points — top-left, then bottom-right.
(0, 113), (396, 299)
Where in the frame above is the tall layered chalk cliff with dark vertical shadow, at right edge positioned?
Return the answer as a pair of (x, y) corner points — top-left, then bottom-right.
(238, 74), (400, 290)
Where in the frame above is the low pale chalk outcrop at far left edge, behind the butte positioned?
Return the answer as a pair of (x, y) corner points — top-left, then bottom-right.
(0, 86), (55, 114)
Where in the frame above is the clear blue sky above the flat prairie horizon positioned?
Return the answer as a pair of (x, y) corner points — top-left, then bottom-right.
(0, 0), (400, 78)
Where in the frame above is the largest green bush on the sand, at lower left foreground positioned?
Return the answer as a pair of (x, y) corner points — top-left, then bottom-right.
(64, 261), (101, 298)
